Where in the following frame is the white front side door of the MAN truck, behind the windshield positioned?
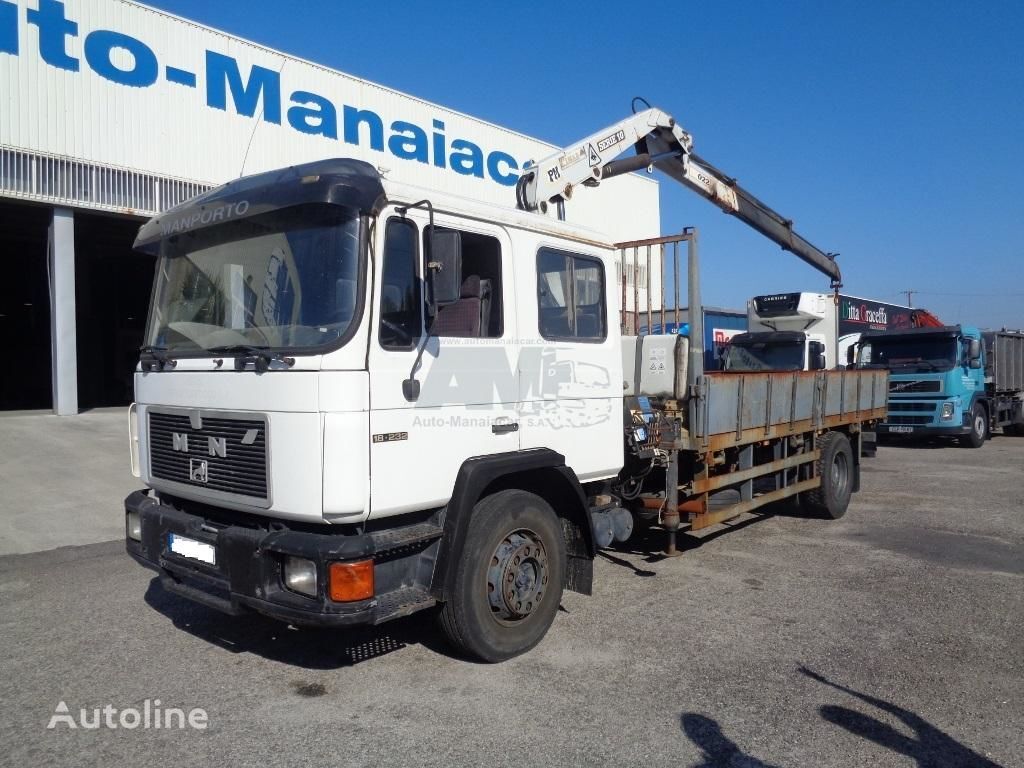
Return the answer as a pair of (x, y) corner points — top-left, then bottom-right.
(368, 210), (519, 515)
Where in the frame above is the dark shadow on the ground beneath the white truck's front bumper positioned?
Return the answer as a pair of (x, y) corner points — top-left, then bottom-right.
(144, 578), (461, 670)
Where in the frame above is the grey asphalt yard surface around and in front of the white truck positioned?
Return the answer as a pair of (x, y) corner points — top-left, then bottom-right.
(0, 437), (1024, 768)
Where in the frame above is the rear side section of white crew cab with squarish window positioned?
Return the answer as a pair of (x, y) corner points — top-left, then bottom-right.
(519, 246), (622, 480)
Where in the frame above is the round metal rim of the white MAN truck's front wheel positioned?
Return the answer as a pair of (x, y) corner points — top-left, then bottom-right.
(487, 528), (549, 624)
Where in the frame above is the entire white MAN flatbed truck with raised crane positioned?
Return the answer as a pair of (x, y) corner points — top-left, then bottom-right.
(125, 110), (887, 662)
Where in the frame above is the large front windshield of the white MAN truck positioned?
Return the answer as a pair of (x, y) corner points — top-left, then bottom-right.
(145, 205), (362, 356)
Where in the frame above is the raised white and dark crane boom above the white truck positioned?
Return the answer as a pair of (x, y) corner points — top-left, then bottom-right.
(516, 109), (842, 288)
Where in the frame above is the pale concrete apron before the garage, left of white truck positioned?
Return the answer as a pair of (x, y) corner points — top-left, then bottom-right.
(0, 408), (139, 555)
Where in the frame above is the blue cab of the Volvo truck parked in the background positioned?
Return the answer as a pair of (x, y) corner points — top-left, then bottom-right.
(857, 326), (992, 447)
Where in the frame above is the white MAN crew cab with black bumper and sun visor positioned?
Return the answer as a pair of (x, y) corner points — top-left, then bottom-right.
(126, 160), (624, 656)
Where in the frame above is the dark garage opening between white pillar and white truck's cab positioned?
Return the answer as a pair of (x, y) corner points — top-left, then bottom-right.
(75, 211), (155, 410)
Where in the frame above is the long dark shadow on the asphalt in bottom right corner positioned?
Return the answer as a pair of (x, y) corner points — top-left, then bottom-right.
(800, 667), (1000, 768)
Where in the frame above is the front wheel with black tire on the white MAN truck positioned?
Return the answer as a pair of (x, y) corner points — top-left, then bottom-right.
(440, 489), (566, 663)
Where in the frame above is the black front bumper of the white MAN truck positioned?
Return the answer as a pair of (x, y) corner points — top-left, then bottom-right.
(125, 490), (440, 627)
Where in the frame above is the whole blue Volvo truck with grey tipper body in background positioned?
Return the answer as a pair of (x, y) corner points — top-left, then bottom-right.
(857, 326), (1024, 447)
